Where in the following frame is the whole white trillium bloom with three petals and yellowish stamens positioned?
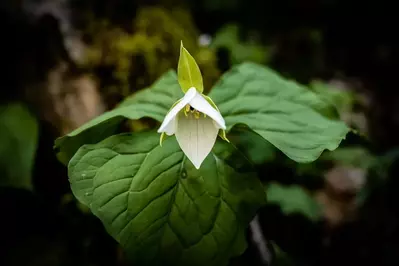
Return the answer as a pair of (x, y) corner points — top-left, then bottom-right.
(158, 87), (226, 169)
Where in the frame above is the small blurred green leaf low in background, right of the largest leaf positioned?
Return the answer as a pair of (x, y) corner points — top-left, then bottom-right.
(266, 183), (322, 221)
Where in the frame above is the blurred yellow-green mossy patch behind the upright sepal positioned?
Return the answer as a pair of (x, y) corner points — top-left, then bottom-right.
(83, 6), (220, 106)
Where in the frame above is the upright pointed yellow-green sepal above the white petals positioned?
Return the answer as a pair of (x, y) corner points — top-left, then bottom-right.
(177, 43), (204, 93)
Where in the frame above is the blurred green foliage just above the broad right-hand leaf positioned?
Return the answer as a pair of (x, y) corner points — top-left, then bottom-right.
(211, 24), (271, 65)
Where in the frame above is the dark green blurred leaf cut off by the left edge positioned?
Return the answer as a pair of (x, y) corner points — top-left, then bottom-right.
(0, 103), (38, 189)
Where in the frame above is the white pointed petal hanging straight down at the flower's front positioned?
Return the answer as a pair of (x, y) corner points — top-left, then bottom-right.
(175, 113), (219, 169)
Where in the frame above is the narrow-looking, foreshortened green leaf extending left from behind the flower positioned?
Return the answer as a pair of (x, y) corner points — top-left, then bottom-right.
(55, 71), (183, 164)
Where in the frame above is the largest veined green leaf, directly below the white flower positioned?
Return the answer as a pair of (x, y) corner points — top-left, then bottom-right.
(69, 132), (265, 266)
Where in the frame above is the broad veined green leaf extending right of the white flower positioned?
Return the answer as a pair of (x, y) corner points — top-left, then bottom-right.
(209, 63), (349, 162)
